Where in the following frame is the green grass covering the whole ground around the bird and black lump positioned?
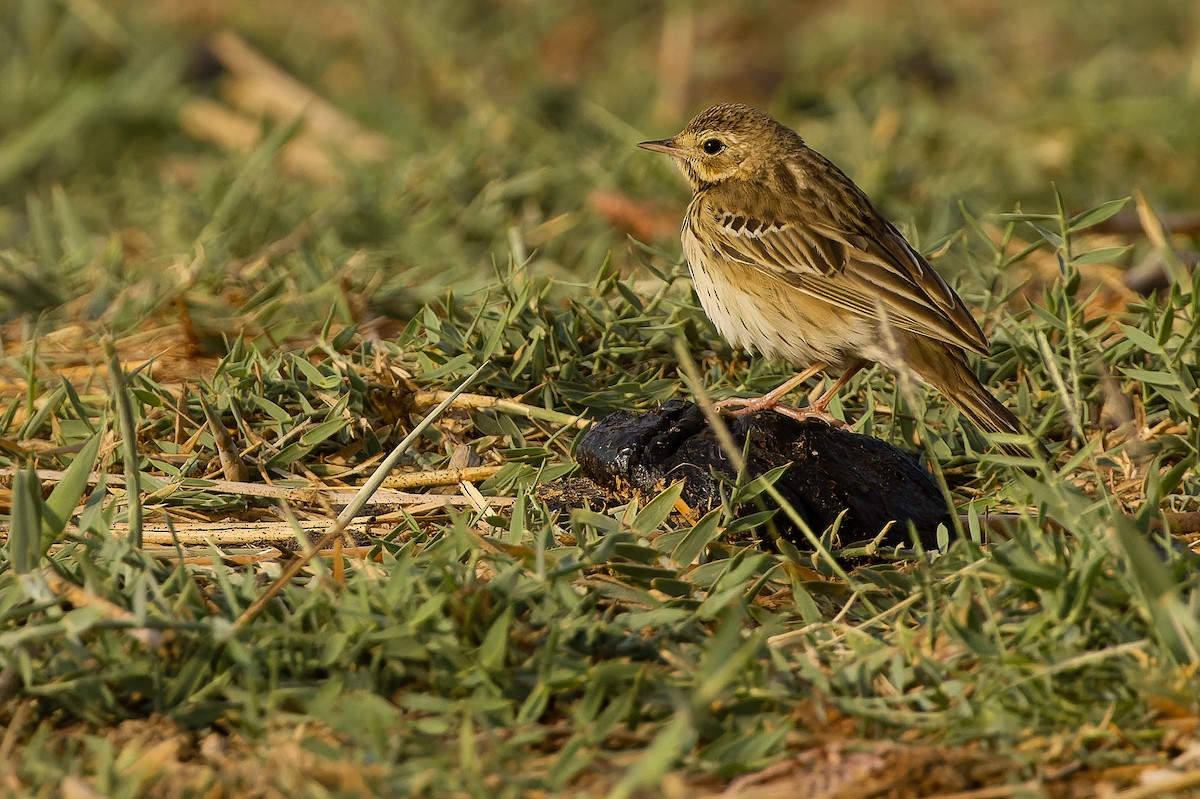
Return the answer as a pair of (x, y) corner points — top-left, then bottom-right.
(0, 1), (1200, 797)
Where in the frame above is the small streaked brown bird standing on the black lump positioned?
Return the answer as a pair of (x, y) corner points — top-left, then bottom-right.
(637, 103), (1027, 456)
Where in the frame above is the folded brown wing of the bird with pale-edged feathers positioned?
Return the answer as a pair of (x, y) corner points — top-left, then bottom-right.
(692, 180), (988, 353)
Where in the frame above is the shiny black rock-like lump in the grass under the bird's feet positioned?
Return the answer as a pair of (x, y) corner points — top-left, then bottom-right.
(576, 400), (952, 548)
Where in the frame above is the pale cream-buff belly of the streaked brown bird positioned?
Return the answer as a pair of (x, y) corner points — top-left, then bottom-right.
(689, 247), (880, 368)
